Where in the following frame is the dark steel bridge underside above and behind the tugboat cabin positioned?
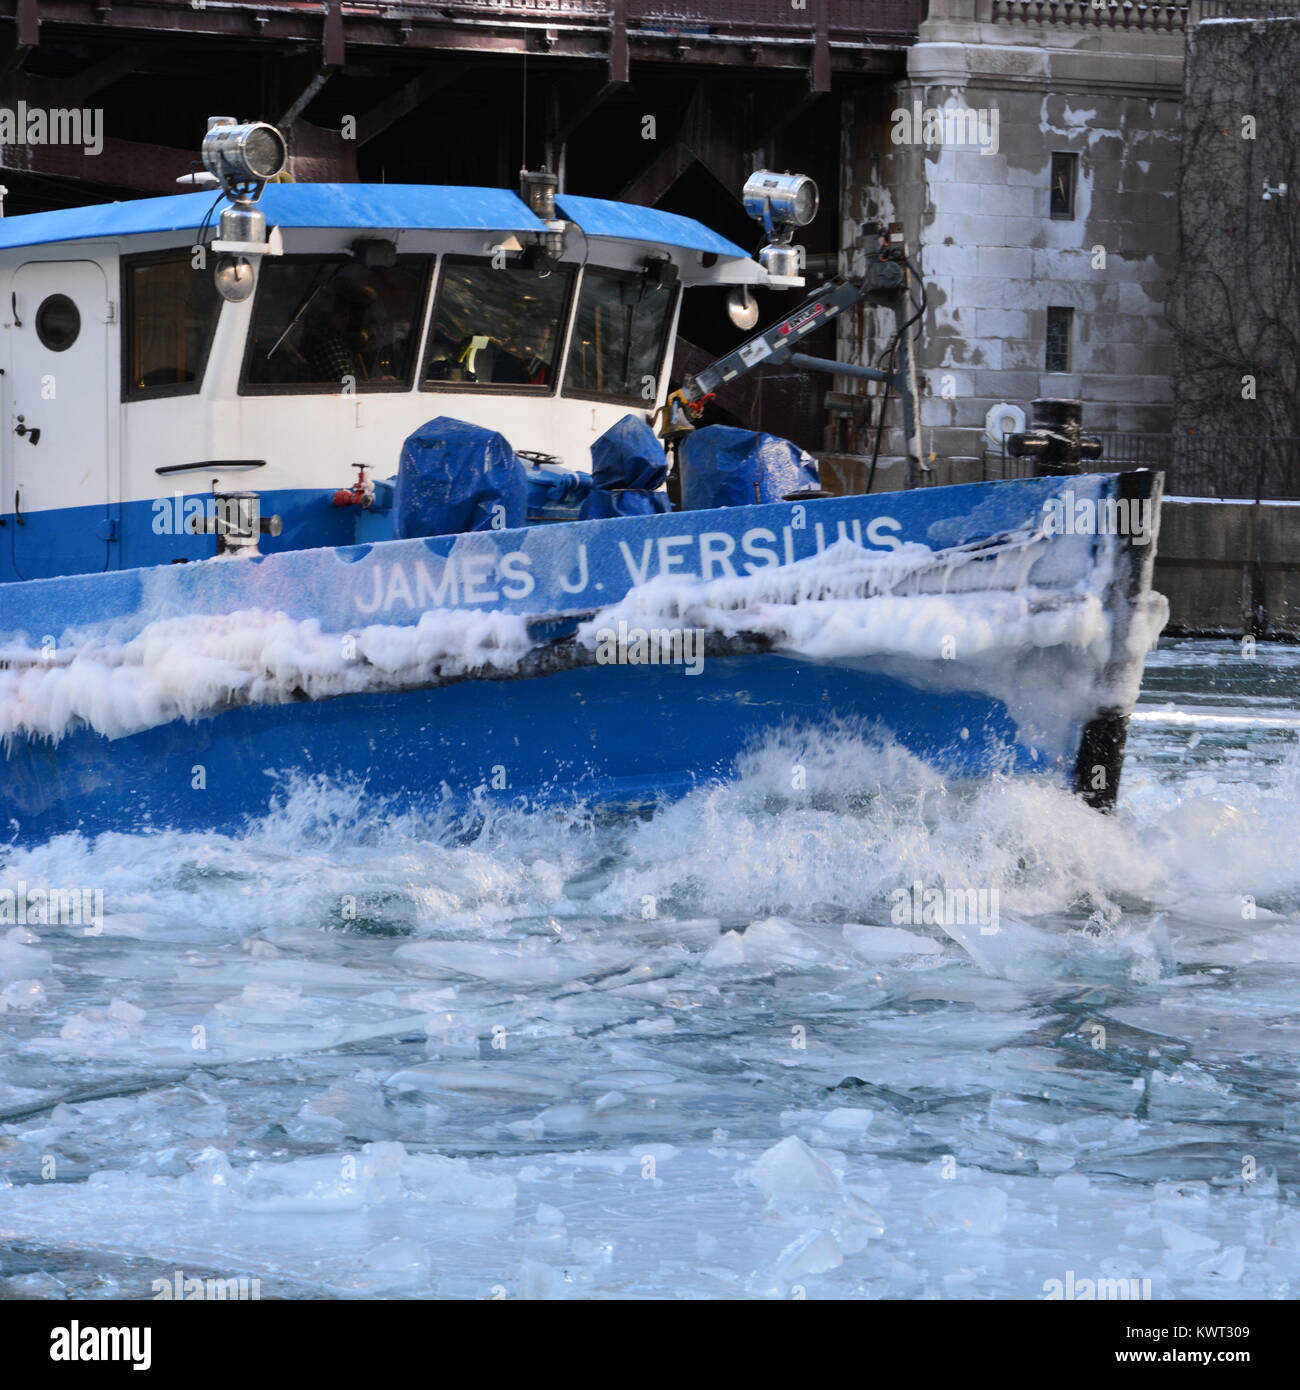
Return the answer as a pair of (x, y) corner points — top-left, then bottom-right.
(0, 0), (922, 448)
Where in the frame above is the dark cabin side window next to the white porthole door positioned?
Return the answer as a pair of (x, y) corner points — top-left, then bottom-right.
(122, 249), (221, 400)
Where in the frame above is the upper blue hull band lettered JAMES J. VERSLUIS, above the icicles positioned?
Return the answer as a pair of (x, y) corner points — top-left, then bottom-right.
(0, 474), (1115, 642)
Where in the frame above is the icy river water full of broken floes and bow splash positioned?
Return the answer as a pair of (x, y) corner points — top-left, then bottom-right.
(0, 642), (1300, 1298)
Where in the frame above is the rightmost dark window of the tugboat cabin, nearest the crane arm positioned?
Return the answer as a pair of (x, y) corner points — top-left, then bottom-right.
(564, 270), (674, 406)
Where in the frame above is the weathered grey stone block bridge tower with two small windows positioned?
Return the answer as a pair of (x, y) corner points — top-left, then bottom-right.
(841, 0), (1183, 456)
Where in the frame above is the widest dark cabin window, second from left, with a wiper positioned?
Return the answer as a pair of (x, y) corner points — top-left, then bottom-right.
(239, 256), (431, 395)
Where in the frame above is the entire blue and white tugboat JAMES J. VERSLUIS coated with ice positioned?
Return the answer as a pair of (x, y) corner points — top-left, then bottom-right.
(0, 117), (1165, 842)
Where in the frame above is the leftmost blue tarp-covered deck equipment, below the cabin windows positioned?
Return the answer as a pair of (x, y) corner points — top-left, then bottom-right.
(393, 416), (528, 541)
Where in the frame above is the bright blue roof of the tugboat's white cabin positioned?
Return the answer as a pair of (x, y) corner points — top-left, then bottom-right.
(0, 183), (748, 256)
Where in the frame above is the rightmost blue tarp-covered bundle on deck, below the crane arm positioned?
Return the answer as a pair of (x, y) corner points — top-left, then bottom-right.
(681, 425), (820, 512)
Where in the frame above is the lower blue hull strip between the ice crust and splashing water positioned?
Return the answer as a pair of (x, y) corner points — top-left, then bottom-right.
(4, 653), (1040, 838)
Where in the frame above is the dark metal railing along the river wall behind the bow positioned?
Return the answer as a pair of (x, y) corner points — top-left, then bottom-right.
(984, 430), (1300, 502)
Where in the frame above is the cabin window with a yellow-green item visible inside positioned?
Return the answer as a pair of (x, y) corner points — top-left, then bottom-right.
(424, 256), (574, 393)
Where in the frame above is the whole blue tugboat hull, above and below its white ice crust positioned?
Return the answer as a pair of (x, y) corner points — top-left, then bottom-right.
(0, 475), (1158, 842)
